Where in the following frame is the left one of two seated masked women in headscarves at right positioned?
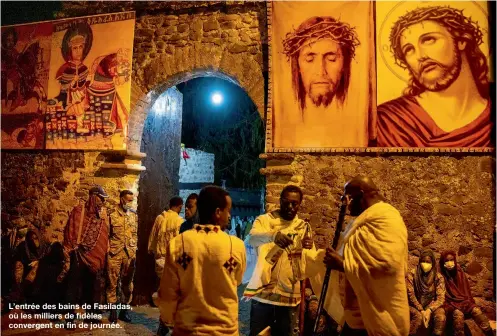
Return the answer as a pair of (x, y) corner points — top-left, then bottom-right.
(407, 250), (445, 335)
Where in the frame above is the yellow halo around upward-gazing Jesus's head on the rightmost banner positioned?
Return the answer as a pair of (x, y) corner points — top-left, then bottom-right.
(377, 0), (489, 83)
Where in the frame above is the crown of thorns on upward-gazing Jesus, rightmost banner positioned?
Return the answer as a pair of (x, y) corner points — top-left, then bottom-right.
(390, 6), (483, 68)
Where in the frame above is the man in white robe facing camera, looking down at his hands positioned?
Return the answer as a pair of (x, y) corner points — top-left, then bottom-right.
(244, 185), (314, 336)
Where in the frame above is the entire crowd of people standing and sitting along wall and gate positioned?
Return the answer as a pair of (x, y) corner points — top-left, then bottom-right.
(2, 176), (493, 336)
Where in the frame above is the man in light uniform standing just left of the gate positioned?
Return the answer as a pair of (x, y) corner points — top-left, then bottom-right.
(107, 190), (138, 322)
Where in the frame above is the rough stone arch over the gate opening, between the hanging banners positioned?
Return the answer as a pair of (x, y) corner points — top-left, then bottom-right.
(111, 4), (267, 303)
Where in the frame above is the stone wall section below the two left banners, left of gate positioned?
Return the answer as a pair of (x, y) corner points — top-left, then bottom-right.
(1, 151), (138, 242)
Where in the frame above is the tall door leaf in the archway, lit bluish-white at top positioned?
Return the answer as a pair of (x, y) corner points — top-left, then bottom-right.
(134, 87), (183, 304)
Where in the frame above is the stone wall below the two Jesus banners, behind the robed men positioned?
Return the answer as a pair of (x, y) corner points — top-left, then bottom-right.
(262, 154), (496, 319)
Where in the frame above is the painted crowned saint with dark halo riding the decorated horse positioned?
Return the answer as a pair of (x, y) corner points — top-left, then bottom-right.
(56, 23), (93, 133)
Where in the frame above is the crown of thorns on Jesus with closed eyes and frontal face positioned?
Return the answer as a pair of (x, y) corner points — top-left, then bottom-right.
(283, 18), (360, 58)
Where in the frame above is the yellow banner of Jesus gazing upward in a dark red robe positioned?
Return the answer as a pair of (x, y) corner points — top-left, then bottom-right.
(376, 1), (493, 148)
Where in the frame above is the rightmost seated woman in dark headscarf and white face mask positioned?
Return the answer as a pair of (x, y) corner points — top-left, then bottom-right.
(440, 251), (493, 336)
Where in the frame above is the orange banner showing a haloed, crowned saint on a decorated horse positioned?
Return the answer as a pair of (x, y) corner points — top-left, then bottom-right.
(45, 12), (135, 150)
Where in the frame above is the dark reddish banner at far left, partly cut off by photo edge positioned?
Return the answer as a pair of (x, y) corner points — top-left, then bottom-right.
(1, 22), (53, 149)
